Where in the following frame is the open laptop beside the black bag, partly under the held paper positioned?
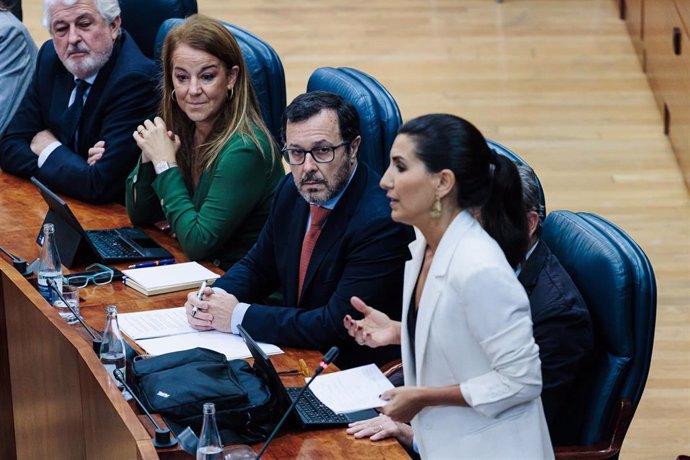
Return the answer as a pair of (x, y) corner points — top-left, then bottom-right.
(237, 325), (379, 429)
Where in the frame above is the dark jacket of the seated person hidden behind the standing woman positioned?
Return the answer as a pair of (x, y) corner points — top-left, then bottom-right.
(518, 241), (594, 441)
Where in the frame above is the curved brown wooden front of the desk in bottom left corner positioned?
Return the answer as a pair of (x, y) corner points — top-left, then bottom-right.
(0, 262), (157, 459)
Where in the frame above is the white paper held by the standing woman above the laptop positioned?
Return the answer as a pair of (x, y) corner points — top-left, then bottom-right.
(309, 364), (393, 414)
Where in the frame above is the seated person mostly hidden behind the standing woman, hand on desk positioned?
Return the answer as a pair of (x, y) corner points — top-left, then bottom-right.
(347, 165), (594, 449)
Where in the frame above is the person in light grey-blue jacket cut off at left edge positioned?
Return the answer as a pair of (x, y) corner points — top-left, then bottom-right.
(0, 0), (38, 137)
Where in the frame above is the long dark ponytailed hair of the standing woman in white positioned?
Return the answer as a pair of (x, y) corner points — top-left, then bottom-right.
(398, 114), (529, 267)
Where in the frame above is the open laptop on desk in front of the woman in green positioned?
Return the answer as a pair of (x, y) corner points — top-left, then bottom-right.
(31, 177), (173, 268)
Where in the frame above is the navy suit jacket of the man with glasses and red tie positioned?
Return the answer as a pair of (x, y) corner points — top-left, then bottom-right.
(214, 163), (414, 368)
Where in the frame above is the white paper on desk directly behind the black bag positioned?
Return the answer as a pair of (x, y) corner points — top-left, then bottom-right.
(136, 331), (283, 359)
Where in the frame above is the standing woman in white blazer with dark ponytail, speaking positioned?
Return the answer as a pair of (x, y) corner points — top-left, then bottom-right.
(344, 114), (553, 459)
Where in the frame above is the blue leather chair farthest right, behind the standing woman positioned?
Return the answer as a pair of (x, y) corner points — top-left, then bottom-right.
(542, 211), (656, 458)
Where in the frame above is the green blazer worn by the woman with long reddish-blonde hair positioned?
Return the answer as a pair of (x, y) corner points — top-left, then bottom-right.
(126, 131), (285, 270)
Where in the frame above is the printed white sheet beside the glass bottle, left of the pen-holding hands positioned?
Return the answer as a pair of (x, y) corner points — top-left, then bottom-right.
(117, 307), (198, 340)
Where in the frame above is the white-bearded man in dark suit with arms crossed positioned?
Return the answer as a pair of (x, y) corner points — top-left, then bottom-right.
(0, 0), (158, 203)
